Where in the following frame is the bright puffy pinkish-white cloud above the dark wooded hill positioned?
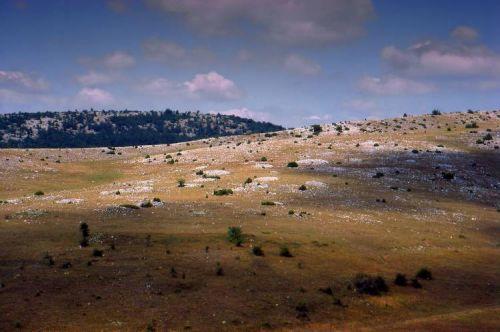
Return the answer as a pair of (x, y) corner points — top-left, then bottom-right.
(183, 71), (242, 100)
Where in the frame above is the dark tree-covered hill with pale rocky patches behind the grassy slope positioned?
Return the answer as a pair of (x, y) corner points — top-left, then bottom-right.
(0, 110), (283, 148)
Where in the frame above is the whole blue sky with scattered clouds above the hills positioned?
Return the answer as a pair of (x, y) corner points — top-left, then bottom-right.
(0, 0), (500, 127)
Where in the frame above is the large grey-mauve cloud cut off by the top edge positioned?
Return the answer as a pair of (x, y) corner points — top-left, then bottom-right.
(147, 0), (374, 45)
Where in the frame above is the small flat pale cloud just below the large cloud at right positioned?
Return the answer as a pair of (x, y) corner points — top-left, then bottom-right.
(359, 76), (434, 95)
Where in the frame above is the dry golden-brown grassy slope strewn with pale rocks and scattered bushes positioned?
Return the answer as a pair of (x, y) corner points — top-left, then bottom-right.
(0, 111), (500, 331)
